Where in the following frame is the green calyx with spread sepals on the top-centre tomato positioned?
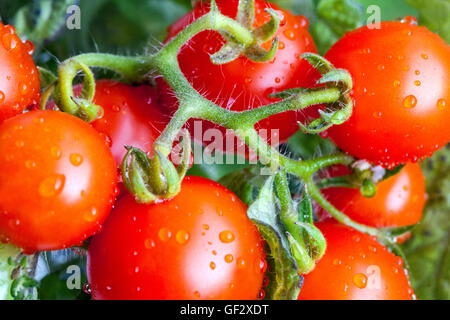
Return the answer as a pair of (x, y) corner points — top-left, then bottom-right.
(210, 0), (281, 65)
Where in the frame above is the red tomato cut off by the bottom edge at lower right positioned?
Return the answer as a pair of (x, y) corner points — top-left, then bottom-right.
(298, 222), (413, 300)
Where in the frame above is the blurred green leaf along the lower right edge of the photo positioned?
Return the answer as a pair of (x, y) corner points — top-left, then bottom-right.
(402, 146), (450, 300)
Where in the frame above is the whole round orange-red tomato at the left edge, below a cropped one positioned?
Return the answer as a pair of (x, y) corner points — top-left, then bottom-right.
(0, 110), (117, 252)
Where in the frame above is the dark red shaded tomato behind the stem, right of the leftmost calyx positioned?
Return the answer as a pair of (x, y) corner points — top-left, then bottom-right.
(74, 80), (170, 165)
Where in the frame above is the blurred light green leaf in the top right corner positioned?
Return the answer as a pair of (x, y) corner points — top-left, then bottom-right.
(406, 0), (450, 44)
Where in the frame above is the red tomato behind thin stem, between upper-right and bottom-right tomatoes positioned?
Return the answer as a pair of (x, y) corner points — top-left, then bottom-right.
(322, 163), (425, 228)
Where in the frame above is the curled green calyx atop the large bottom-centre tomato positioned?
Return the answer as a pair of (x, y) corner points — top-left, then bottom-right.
(121, 130), (191, 203)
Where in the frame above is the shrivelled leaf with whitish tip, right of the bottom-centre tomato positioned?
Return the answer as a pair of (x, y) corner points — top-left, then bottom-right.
(247, 176), (302, 300)
